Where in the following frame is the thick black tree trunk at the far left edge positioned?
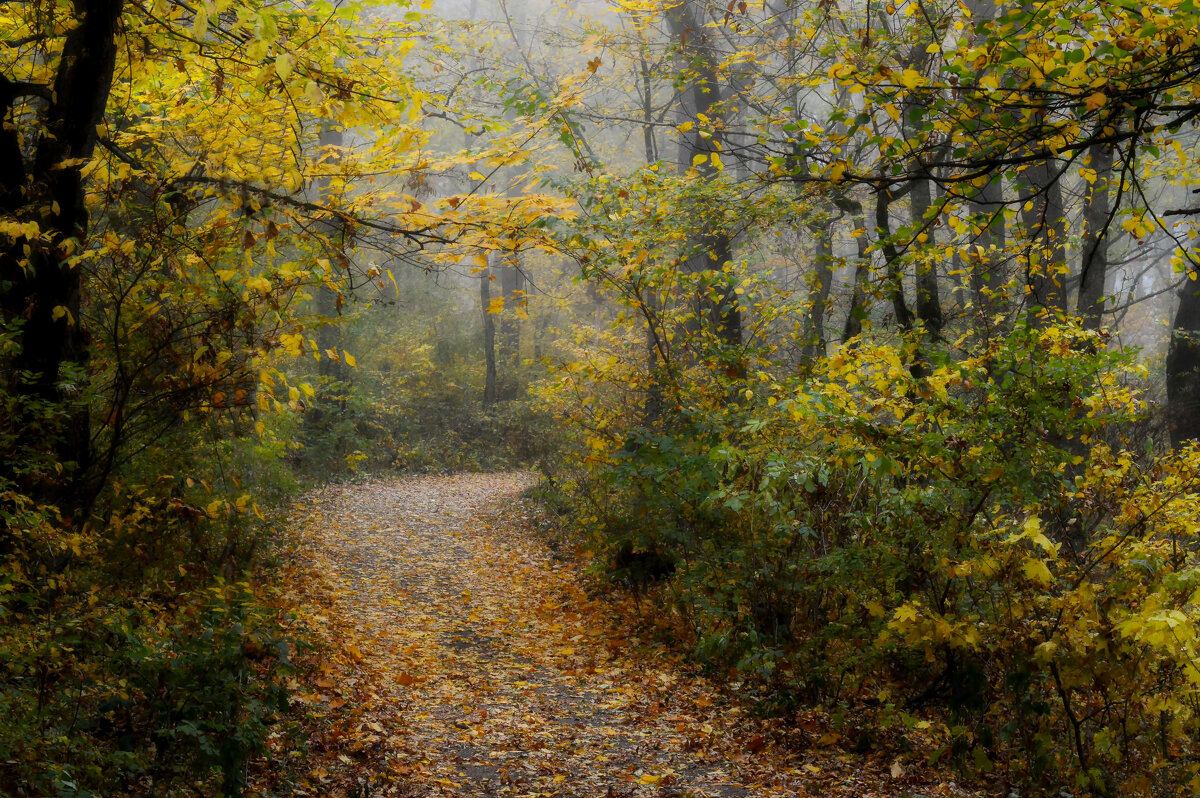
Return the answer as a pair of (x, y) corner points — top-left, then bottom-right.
(0, 0), (122, 504)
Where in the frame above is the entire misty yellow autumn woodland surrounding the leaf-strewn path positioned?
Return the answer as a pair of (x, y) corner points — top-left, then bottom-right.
(7, 0), (1200, 796)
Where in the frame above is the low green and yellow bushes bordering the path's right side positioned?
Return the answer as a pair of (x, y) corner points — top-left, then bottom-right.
(556, 325), (1200, 794)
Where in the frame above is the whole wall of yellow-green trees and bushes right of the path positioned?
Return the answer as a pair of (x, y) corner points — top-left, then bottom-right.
(546, 2), (1200, 794)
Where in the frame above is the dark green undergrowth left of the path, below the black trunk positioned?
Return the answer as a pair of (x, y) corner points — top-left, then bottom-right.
(0, 352), (302, 796)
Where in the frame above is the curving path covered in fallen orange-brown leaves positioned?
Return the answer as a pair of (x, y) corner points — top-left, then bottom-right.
(265, 473), (982, 798)
